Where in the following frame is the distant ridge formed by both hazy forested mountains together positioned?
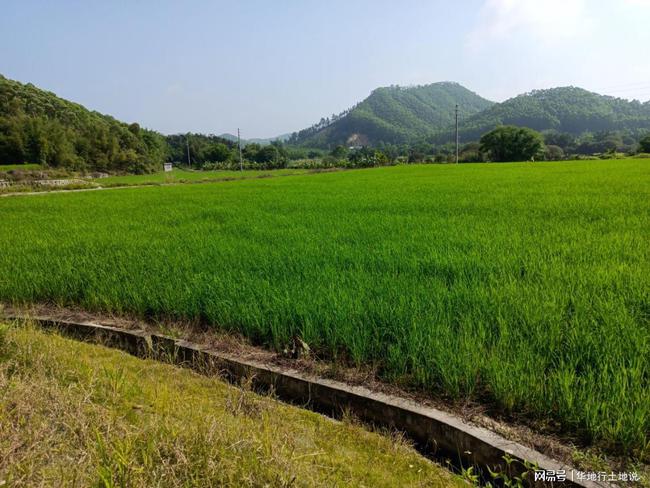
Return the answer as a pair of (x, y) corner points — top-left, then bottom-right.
(288, 82), (650, 148)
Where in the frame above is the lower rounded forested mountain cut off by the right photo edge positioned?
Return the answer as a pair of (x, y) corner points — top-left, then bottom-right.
(450, 87), (650, 142)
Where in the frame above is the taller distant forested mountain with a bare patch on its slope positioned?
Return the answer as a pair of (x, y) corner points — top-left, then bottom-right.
(288, 82), (493, 148)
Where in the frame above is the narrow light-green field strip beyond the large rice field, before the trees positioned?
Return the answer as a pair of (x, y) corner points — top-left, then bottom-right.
(94, 168), (306, 186)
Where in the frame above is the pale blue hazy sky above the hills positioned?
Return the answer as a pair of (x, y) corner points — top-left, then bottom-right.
(0, 0), (650, 137)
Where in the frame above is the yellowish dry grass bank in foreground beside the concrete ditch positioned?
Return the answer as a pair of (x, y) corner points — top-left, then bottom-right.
(0, 326), (462, 488)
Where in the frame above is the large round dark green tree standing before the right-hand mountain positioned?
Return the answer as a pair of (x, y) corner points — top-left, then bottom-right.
(481, 125), (544, 162)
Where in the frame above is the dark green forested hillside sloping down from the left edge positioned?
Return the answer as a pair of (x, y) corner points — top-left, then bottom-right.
(0, 75), (167, 172)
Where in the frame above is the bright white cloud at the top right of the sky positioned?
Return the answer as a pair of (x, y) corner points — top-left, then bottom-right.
(468, 0), (592, 49)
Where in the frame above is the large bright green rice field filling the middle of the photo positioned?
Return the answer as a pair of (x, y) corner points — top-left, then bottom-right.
(0, 160), (650, 459)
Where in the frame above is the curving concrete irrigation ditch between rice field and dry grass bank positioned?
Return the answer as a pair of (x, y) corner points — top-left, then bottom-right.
(5, 314), (610, 487)
